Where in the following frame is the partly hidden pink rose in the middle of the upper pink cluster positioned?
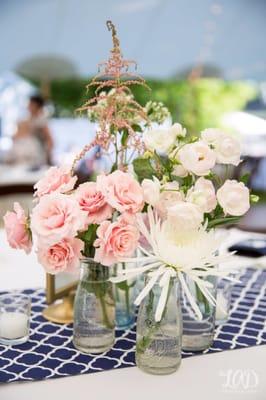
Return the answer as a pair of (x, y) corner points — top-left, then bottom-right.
(75, 182), (112, 225)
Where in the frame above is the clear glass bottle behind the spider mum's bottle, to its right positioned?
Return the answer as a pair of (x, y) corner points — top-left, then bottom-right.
(182, 276), (217, 351)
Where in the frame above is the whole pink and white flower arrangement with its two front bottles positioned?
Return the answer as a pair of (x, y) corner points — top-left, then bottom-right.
(4, 21), (254, 373)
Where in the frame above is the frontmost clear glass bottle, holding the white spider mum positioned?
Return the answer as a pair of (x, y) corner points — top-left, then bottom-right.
(136, 275), (182, 375)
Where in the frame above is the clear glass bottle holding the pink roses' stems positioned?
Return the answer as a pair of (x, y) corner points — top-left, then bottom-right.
(73, 258), (115, 353)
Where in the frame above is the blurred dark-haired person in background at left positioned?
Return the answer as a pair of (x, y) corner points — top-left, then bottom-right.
(7, 95), (53, 169)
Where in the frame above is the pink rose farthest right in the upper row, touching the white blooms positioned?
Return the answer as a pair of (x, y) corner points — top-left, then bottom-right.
(97, 171), (144, 213)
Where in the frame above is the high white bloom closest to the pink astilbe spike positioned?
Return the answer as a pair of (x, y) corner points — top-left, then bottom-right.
(143, 128), (176, 154)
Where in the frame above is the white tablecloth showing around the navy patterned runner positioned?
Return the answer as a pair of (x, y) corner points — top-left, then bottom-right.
(0, 230), (266, 400)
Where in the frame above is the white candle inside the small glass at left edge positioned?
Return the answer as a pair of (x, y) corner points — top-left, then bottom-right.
(0, 312), (29, 339)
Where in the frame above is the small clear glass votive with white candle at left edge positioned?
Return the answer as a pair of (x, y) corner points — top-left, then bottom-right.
(0, 293), (31, 345)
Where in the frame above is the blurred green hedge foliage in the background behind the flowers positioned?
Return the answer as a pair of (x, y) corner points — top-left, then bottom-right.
(44, 78), (257, 133)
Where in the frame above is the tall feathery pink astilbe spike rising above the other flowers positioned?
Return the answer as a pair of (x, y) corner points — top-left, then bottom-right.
(72, 21), (149, 173)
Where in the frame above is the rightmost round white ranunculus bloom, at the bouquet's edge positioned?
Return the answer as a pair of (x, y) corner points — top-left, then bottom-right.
(217, 179), (250, 216)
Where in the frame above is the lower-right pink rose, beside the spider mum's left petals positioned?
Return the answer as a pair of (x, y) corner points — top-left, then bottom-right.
(94, 217), (139, 266)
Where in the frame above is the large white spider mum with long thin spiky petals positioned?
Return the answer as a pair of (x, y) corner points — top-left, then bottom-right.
(111, 207), (235, 321)
